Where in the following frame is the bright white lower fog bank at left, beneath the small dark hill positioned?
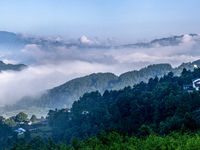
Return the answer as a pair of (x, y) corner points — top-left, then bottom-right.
(0, 61), (114, 105)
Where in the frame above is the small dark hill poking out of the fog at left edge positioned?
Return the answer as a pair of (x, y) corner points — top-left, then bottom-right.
(0, 61), (27, 72)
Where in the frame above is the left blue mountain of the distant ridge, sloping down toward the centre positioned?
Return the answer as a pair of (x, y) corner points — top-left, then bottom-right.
(0, 31), (110, 50)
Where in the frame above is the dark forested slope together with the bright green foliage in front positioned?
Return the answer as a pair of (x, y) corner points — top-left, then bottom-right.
(3, 68), (200, 149)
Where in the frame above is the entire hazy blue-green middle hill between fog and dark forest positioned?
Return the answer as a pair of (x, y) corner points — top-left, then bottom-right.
(6, 60), (200, 113)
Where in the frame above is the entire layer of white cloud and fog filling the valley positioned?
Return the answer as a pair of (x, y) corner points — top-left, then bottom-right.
(0, 35), (200, 103)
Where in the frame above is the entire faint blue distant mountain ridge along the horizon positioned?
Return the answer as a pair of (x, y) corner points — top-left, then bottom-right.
(0, 31), (197, 49)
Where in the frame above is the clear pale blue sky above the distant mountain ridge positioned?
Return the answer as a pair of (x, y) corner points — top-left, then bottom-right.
(0, 0), (200, 43)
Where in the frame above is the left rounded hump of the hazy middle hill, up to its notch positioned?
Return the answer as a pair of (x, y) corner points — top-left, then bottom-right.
(9, 73), (118, 109)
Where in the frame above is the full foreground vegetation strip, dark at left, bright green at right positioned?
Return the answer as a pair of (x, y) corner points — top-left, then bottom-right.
(5, 132), (200, 150)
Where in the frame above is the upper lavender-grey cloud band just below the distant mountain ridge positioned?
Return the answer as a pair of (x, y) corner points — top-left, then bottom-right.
(18, 35), (200, 69)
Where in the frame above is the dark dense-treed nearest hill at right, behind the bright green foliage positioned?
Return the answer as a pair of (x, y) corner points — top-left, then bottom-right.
(47, 68), (200, 142)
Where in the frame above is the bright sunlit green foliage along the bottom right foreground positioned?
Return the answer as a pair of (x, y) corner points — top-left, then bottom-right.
(68, 132), (200, 150)
